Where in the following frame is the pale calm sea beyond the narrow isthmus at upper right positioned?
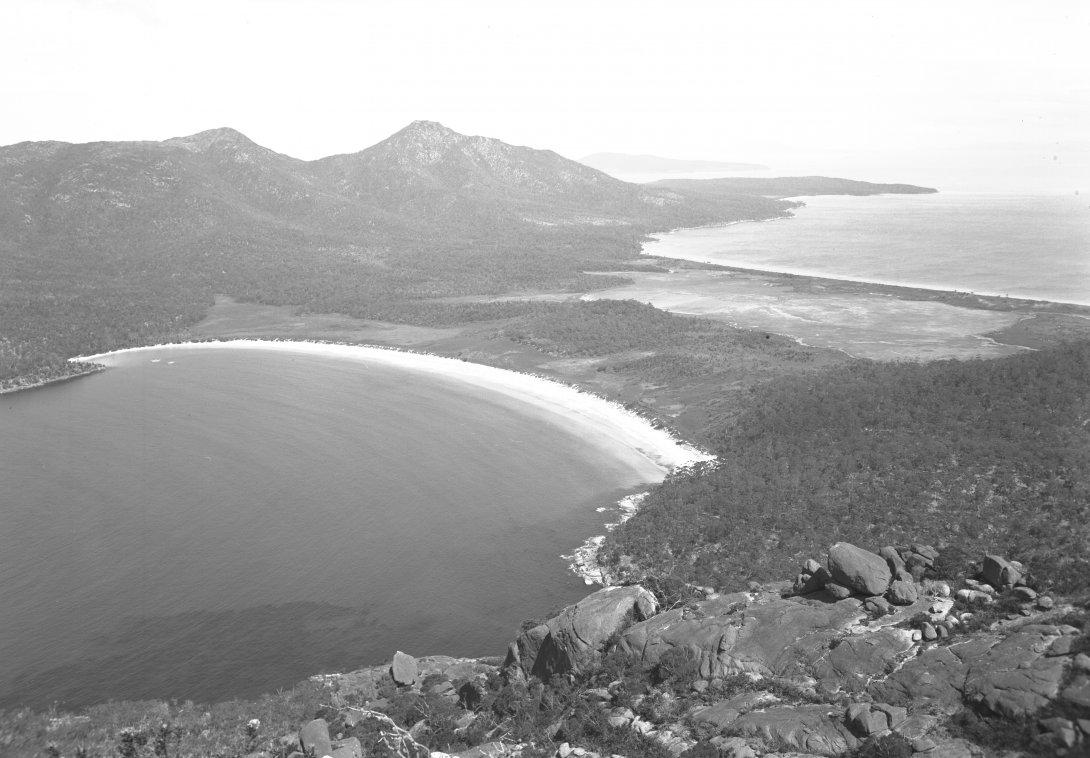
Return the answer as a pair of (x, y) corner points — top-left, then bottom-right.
(644, 193), (1090, 304)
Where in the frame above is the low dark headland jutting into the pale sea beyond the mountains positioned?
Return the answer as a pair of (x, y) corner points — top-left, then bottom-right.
(646, 177), (938, 197)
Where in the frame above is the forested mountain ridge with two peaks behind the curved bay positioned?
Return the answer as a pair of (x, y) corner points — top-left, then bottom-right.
(0, 121), (791, 382)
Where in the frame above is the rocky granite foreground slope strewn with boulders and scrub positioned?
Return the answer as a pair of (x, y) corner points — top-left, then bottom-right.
(268, 543), (1090, 758)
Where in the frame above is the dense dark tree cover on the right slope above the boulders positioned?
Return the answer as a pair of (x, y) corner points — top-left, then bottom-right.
(603, 342), (1090, 592)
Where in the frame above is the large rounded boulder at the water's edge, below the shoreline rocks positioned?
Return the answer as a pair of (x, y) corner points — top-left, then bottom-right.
(504, 585), (658, 679)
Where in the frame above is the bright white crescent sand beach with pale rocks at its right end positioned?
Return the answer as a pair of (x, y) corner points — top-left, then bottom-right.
(72, 339), (714, 583)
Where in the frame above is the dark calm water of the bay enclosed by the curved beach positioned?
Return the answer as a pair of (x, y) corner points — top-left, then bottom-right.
(0, 351), (645, 706)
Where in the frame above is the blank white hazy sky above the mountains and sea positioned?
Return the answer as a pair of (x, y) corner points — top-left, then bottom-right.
(0, 0), (1090, 193)
